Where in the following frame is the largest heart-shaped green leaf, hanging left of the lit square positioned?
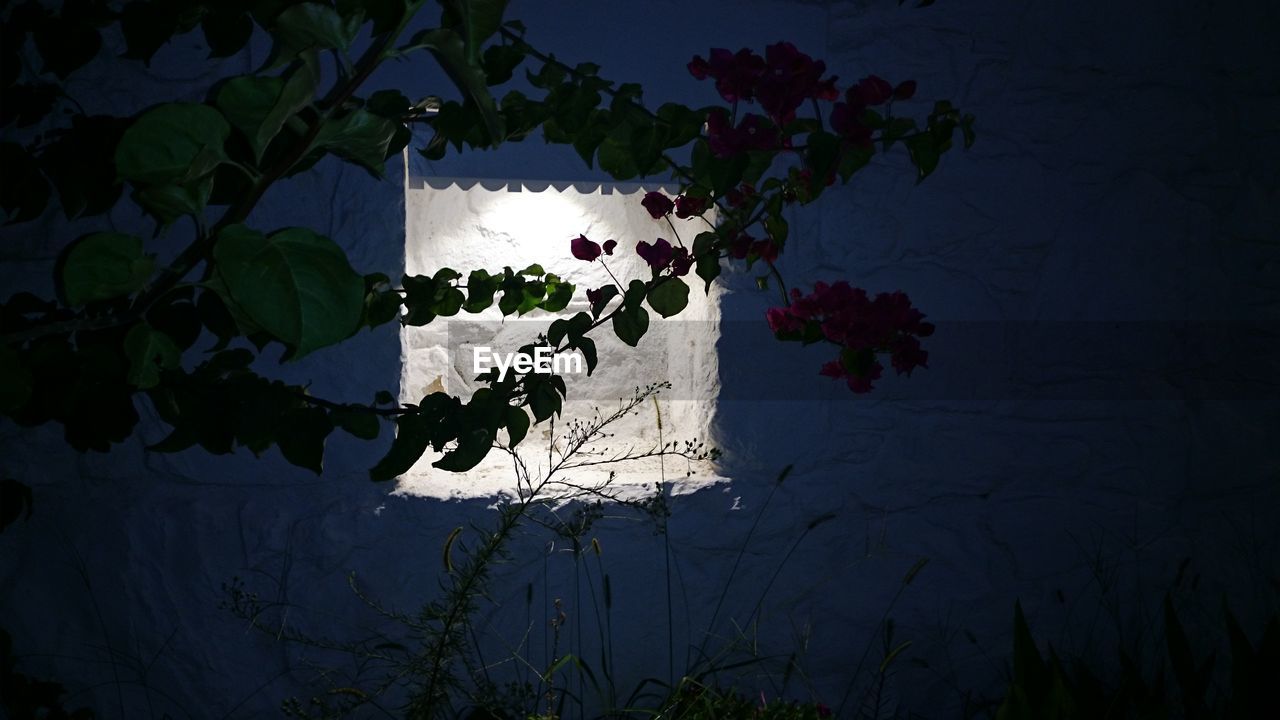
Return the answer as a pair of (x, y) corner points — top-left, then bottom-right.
(214, 225), (365, 357)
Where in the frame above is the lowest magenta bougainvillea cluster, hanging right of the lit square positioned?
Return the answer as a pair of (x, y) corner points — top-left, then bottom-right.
(765, 281), (934, 392)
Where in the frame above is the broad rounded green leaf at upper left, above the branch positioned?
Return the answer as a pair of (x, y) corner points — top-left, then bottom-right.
(115, 102), (232, 184)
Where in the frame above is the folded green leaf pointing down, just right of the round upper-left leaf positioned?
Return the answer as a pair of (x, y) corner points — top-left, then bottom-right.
(215, 54), (319, 159)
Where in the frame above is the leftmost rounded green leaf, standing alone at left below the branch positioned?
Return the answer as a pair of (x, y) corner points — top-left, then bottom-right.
(61, 232), (155, 307)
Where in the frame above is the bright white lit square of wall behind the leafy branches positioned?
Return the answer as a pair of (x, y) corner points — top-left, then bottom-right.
(398, 178), (721, 498)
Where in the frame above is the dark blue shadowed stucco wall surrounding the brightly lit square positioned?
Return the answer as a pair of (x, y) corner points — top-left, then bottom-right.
(0, 0), (1280, 719)
